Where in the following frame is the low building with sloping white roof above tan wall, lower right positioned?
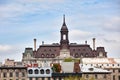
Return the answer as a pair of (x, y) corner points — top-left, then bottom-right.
(80, 64), (112, 80)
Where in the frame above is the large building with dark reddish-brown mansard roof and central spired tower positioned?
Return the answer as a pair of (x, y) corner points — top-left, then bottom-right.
(22, 16), (107, 66)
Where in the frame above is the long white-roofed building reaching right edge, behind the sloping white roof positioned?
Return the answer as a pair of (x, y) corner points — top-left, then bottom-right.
(81, 58), (120, 80)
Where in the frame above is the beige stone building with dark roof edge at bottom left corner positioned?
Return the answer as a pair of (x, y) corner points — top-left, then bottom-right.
(0, 67), (28, 80)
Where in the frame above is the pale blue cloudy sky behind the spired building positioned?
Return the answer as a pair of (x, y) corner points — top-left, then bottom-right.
(0, 0), (120, 62)
